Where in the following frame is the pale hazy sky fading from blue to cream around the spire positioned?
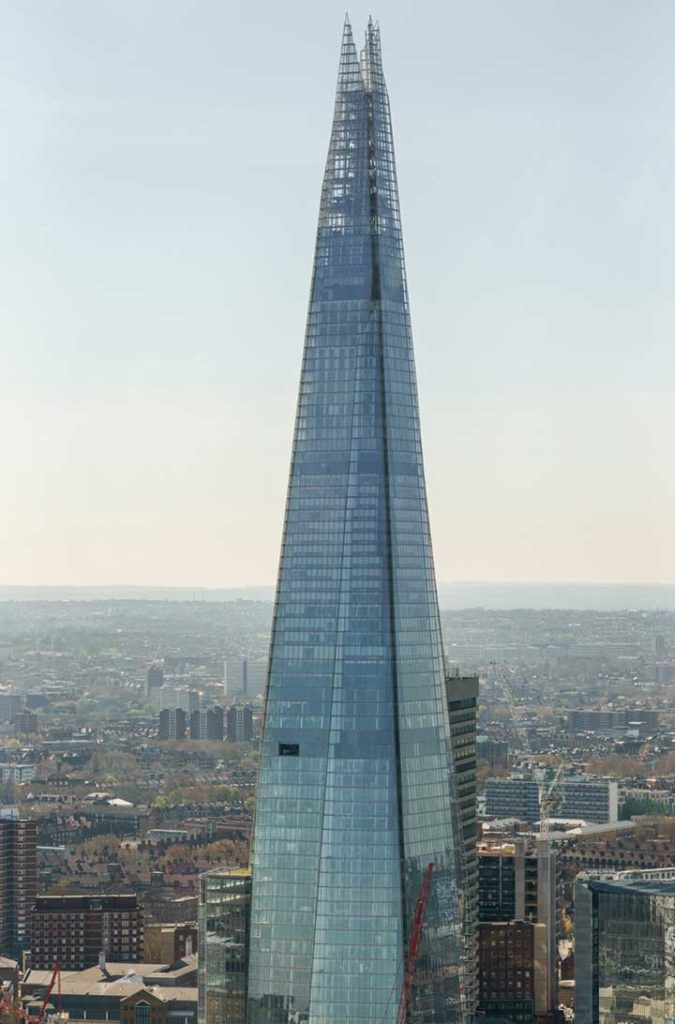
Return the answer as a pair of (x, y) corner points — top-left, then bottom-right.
(0, 0), (675, 586)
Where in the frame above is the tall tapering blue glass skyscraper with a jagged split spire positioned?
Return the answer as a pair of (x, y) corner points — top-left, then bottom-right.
(247, 23), (462, 1024)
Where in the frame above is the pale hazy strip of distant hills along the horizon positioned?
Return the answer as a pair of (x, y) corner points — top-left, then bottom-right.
(0, 583), (675, 611)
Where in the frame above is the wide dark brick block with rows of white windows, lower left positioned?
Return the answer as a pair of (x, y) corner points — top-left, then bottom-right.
(31, 895), (143, 971)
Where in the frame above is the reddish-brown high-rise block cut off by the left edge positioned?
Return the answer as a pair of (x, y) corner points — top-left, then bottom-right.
(0, 807), (38, 959)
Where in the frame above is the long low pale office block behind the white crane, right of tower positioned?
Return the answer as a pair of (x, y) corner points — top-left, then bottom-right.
(486, 770), (619, 824)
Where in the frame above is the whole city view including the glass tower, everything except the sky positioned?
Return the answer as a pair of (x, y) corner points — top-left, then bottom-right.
(0, 9), (675, 1024)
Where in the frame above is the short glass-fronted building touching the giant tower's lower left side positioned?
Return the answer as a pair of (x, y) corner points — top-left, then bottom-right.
(199, 868), (251, 1024)
